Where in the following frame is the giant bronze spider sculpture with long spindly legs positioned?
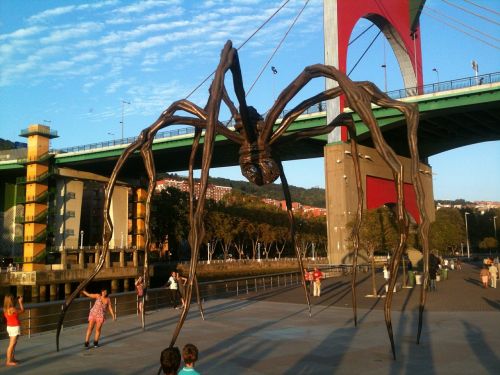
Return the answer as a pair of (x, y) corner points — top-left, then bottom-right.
(56, 41), (429, 358)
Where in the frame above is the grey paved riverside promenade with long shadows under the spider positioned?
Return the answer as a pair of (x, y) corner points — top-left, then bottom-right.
(0, 265), (500, 375)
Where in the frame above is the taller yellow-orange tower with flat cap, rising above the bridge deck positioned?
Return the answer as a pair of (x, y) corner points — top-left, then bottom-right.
(20, 124), (57, 271)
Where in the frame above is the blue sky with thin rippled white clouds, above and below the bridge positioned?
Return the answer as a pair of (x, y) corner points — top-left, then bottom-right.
(0, 0), (500, 201)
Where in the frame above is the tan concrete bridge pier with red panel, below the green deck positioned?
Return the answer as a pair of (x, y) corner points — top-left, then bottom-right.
(325, 143), (434, 264)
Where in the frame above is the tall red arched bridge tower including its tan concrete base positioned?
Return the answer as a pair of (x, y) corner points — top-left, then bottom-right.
(324, 0), (434, 264)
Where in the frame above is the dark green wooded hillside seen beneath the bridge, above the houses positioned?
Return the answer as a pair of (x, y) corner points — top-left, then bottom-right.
(157, 173), (326, 208)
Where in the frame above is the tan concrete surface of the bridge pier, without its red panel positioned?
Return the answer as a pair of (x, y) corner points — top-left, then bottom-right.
(325, 143), (434, 264)
